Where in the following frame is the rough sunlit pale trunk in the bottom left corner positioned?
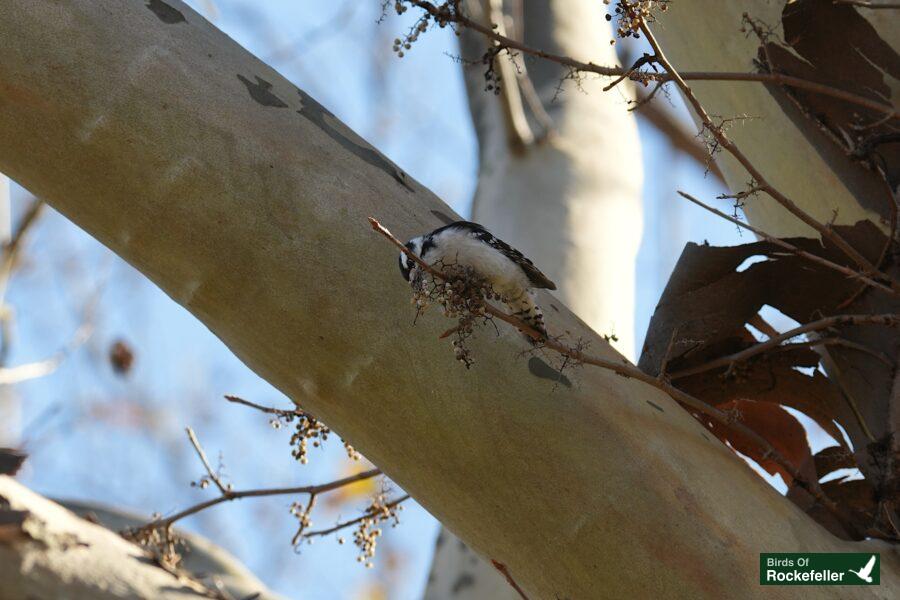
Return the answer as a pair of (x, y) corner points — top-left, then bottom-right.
(0, 475), (281, 600)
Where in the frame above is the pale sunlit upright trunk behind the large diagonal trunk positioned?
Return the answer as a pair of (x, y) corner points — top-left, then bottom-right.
(425, 0), (643, 600)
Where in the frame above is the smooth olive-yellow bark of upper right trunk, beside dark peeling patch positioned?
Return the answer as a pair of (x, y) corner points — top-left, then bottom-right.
(652, 0), (900, 237)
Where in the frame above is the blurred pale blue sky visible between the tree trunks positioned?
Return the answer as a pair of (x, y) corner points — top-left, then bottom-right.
(1, 0), (772, 599)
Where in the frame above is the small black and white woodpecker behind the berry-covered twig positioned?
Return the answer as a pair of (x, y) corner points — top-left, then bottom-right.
(400, 221), (556, 337)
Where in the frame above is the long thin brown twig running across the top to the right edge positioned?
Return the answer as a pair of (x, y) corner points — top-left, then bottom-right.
(407, 0), (900, 119)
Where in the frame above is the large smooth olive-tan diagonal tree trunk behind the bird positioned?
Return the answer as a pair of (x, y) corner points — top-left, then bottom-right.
(0, 0), (900, 598)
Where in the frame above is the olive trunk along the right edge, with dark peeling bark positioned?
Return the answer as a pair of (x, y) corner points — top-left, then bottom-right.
(653, 0), (900, 532)
